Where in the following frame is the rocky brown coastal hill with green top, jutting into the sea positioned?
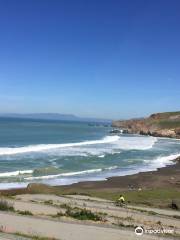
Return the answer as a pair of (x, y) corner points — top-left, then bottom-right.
(112, 111), (180, 138)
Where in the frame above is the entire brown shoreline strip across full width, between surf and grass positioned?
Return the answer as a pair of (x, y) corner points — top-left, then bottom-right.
(0, 157), (180, 194)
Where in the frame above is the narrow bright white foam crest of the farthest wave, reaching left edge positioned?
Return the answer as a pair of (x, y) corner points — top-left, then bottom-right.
(0, 136), (120, 155)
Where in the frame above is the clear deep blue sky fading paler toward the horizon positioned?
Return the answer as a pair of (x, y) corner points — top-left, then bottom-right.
(0, 0), (180, 119)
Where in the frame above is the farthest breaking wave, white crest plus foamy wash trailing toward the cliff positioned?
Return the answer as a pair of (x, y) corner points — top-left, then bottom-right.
(0, 135), (157, 156)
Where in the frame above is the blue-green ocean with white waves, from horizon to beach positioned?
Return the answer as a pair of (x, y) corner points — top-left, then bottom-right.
(0, 118), (180, 189)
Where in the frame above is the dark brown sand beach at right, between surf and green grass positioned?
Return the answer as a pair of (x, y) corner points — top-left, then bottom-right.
(59, 157), (180, 191)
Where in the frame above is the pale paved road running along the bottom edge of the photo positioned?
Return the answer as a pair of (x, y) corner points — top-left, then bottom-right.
(0, 212), (167, 240)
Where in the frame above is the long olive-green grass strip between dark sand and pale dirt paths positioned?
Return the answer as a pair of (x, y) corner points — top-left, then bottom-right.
(1, 184), (180, 208)
